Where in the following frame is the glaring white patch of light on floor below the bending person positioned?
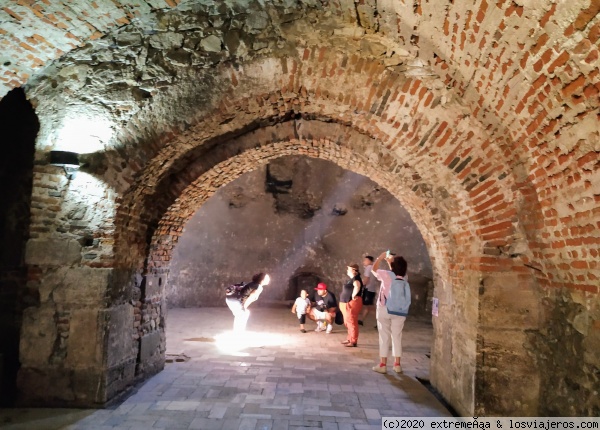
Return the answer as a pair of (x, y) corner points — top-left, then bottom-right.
(215, 330), (290, 357)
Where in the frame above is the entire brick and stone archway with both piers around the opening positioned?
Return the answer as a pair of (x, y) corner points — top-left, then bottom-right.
(11, 1), (599, 414)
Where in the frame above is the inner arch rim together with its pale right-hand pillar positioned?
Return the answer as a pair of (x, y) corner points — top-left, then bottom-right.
(106, 110), (535, 413)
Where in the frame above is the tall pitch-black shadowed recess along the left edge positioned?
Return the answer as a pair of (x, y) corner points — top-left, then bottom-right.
(0, 89), (38, 406)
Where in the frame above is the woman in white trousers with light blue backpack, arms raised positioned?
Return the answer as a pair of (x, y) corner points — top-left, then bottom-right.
(371, 251), (411, 373)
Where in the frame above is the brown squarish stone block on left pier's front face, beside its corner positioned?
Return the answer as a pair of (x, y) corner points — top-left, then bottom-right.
(65, 309), (104, 368)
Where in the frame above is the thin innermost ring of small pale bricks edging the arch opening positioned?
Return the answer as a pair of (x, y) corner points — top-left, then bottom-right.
(147, 133), (452, 278)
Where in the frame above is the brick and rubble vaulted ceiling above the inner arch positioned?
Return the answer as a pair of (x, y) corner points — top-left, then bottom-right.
(0, 0), (600, 292)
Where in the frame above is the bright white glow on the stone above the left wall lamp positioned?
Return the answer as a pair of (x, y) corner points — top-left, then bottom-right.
(55, 111), (113, 154)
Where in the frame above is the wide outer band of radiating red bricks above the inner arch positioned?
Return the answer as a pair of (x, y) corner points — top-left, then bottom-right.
(110, 47), (545, 288)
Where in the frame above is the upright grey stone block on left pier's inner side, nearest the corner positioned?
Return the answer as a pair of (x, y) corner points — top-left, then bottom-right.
(103, 304), (135, 367)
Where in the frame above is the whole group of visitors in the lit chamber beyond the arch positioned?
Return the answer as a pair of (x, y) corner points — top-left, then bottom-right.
(226, 251), (410, 373)
